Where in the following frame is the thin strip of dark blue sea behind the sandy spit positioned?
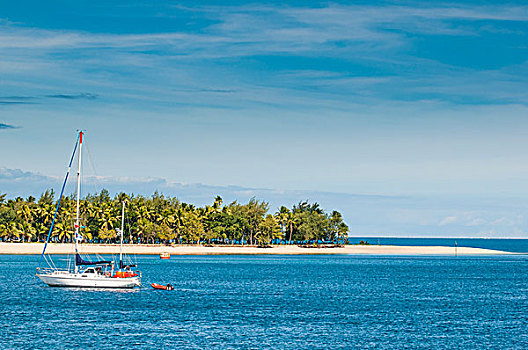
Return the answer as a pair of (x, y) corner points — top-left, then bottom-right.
(349, 237), (528, 253)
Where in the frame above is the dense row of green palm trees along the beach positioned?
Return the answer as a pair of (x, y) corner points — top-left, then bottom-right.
(0, 190), (349, 245)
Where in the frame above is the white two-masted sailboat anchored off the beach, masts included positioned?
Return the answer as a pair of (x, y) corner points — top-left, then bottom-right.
(37, 131), (141, 289)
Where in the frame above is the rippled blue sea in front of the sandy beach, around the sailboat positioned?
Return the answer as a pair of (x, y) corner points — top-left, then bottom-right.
(0, 255), (528, 349)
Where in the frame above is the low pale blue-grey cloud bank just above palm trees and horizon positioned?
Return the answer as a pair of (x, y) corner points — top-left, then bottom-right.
(0, 167), (528, 237)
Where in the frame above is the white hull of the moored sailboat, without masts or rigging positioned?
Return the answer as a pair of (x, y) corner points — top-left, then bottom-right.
(37, 272), (141, 289)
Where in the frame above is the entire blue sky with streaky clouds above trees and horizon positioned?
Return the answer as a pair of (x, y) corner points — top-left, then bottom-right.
(0, 0), (528, 238)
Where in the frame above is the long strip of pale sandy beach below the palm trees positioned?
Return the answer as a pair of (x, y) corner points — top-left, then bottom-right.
(0, 243), (519, 256)
